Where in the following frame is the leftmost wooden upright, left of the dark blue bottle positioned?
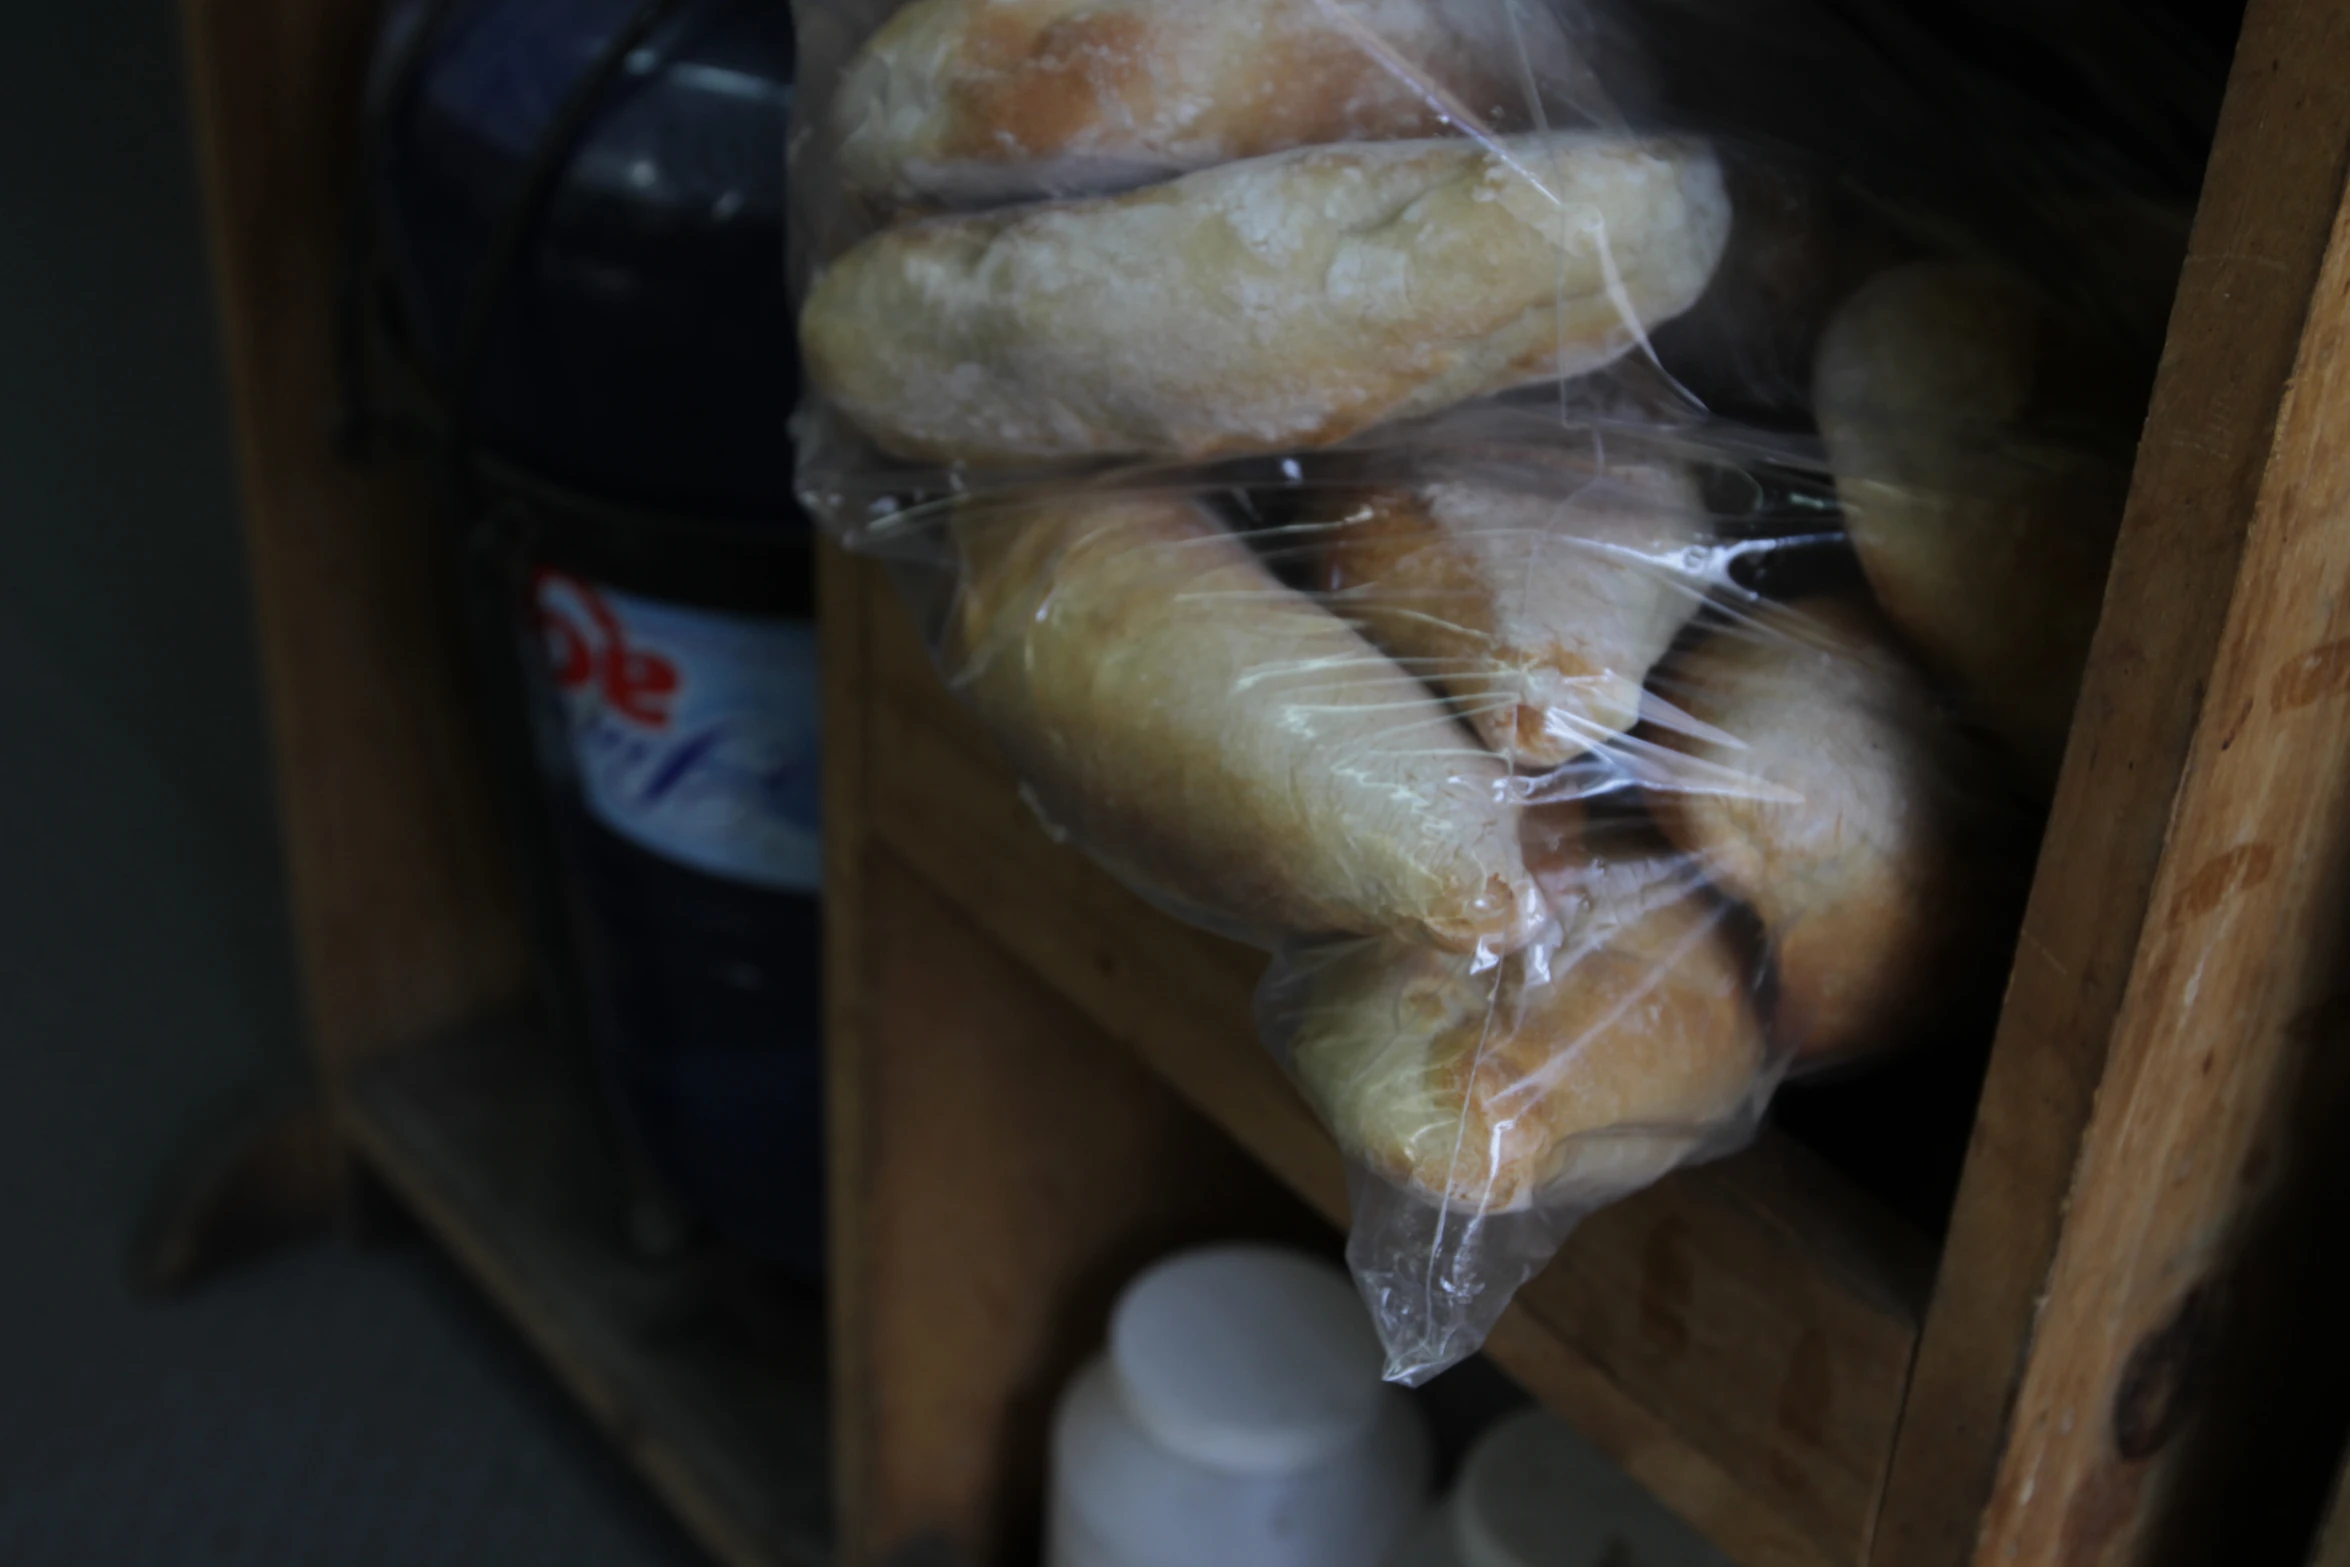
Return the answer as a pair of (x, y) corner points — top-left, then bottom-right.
(181, 0), (526, 1088)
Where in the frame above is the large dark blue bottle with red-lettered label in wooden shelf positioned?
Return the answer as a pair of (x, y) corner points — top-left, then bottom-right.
(374, 0), (823, 1271)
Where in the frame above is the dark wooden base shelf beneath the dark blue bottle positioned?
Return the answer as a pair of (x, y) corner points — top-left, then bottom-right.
(343, 1029), (832, 1567)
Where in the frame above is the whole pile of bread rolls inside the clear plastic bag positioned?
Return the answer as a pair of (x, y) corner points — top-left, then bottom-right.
(801, 0), (2117, 1212)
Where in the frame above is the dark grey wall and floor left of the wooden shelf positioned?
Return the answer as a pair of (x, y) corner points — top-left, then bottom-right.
(0, 0), (698, 1567)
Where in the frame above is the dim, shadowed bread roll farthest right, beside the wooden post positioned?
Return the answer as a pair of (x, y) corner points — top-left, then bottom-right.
(1814, 263), (2143, 785)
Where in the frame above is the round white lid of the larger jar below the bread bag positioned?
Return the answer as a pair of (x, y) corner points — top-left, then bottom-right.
(1109, 1245), (1384, 1473)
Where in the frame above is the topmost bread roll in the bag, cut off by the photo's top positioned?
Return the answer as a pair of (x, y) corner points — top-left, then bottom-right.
(832, 0), (1520, 207)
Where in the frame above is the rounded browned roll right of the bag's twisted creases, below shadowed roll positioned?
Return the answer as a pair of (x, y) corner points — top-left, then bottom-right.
(1650, 599), (1974, 1062)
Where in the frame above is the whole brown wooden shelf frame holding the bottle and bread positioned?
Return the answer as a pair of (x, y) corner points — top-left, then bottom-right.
(183, 0), (2350, 1567)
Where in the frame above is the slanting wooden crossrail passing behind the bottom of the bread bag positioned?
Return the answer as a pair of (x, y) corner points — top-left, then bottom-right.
(827, 552), (1929, 1565)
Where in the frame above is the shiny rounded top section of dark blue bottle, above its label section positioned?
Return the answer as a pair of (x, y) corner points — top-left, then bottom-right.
(381, 0), (799, 514)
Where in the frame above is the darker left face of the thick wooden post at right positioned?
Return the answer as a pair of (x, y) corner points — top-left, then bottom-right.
(1873, 0), (2350, 1567)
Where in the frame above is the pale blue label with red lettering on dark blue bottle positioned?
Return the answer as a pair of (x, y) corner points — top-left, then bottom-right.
(533, 571), (823, 893)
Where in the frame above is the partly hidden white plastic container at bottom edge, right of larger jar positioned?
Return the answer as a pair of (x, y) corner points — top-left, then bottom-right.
(1394, 1410), (1732, 1567)
